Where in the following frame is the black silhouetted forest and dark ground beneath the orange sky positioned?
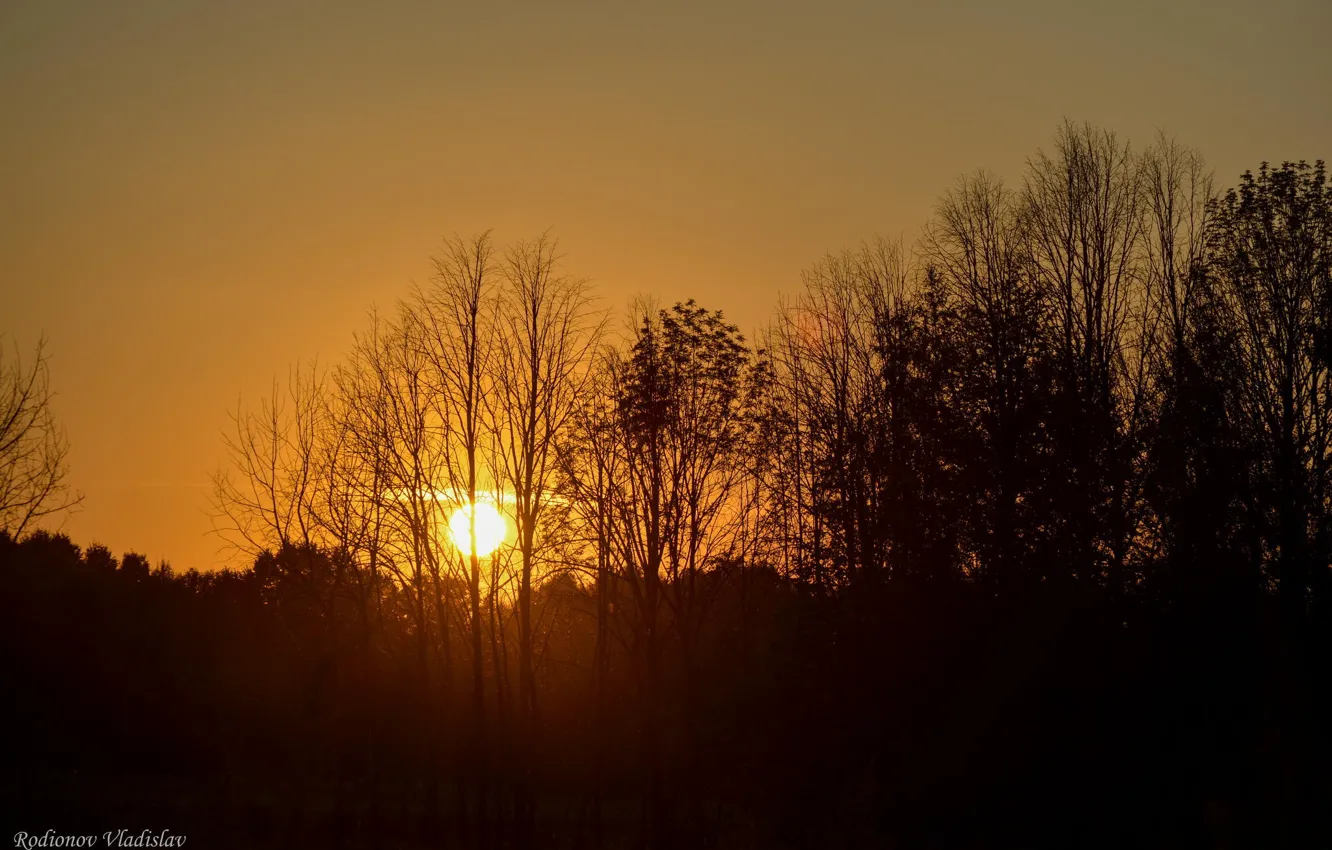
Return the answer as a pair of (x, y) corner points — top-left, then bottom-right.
(0, 123), (1332, 847)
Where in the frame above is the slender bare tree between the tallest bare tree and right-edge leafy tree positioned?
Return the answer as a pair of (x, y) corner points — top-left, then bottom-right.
(1142, 135), (1255, 604)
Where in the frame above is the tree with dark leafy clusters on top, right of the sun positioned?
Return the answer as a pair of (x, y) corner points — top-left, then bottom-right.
(609, 300), (755, 829)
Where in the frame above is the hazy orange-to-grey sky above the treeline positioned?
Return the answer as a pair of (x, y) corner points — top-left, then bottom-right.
(0, 0), (1332, 568)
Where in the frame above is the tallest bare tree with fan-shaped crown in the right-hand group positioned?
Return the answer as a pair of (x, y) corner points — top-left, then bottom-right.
(1022, 123), (1156, 588)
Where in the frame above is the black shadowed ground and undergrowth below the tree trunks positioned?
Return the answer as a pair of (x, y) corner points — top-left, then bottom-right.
(0, 537), (1332, 847)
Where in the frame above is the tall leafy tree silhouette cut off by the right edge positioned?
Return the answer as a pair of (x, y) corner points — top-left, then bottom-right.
(1208, 161), (1332, 614)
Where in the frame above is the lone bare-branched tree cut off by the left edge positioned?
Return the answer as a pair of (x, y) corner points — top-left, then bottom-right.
(0, 340), (83, 538)
